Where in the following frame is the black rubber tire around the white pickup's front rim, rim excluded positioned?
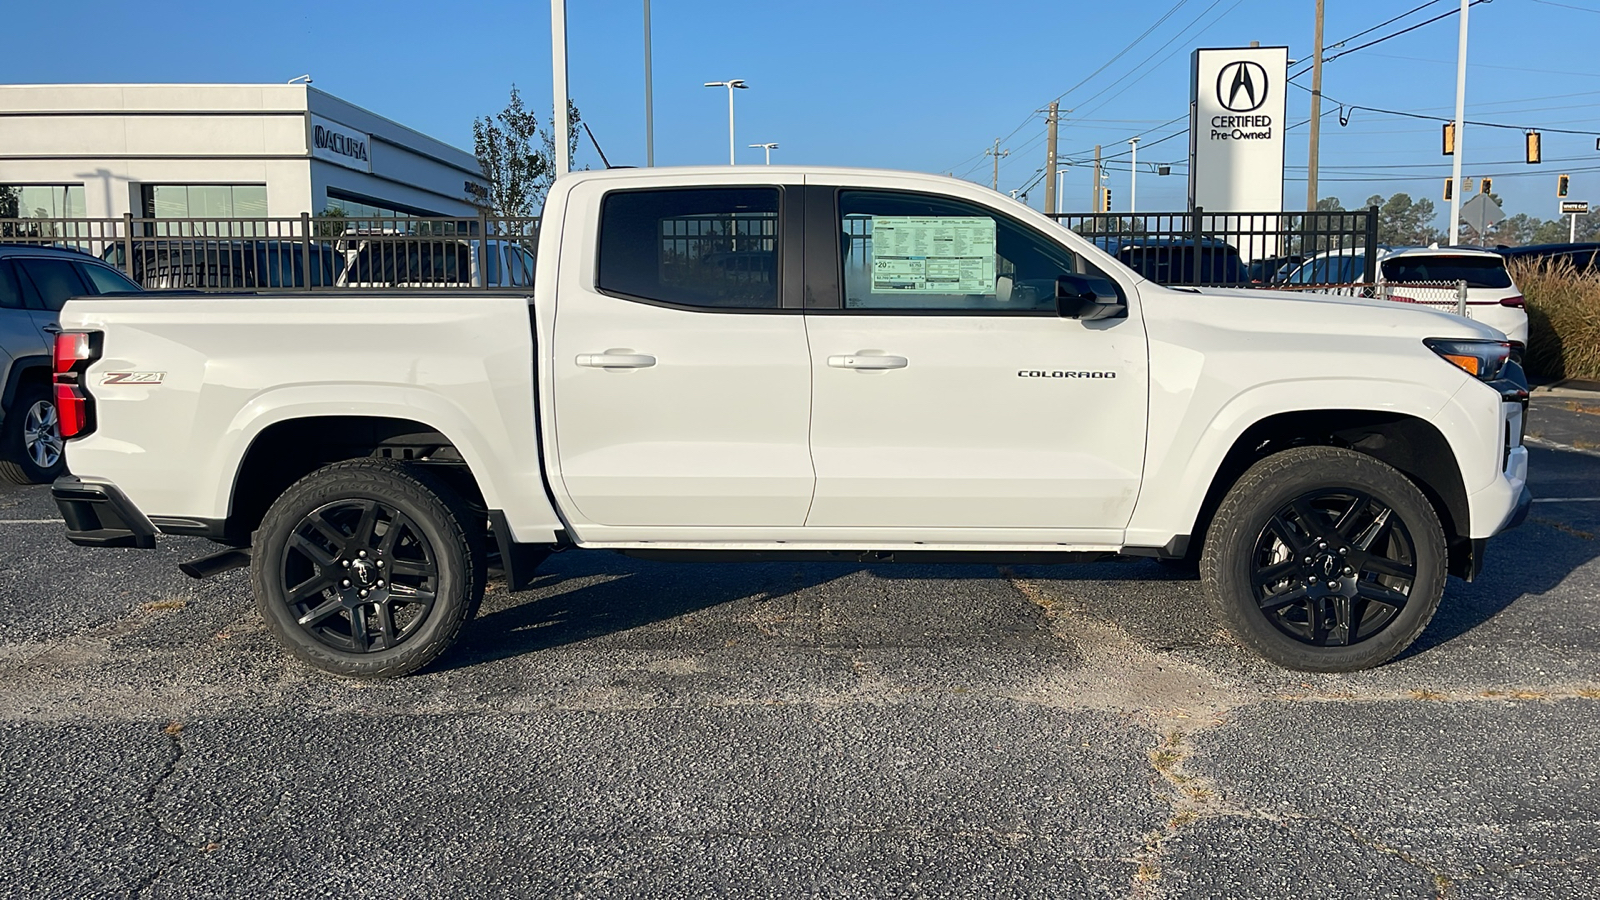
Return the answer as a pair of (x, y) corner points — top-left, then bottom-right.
(1200, 447), (1448, 671)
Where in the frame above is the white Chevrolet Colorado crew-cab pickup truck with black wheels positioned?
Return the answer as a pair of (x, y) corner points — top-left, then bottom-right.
(43, 167), (1530, 676)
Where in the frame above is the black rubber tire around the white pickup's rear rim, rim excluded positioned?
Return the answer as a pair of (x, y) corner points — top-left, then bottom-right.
(251, 458), (486, 677)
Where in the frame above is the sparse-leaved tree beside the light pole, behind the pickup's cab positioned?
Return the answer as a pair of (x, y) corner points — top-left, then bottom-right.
(467, 85), (579, 216)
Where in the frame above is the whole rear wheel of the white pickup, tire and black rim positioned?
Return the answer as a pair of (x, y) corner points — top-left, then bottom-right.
(251, 460), (485, 677)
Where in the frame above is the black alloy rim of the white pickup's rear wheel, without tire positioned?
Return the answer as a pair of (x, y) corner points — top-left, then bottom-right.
(282, 498), (438, 653)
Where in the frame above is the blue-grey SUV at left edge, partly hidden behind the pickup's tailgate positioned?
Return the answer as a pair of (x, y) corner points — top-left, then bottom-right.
(0, 243), (139, 484)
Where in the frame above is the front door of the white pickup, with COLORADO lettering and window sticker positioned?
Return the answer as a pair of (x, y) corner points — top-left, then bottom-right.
(806, 189), (1149, 528)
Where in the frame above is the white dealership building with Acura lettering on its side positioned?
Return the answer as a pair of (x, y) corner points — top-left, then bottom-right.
(0, 83), (485, 218)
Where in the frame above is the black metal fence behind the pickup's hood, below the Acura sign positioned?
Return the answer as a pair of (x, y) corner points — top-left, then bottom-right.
(1054, 207), (1378, 290)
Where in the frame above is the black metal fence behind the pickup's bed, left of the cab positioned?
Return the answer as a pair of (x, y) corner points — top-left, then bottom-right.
(0, 215), (539, 290)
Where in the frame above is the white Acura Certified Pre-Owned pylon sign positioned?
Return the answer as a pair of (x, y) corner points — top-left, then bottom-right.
(1189, 46), (1290, 220)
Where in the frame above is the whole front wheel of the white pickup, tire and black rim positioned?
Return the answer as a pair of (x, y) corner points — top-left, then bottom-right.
(1200, 447), (1446, 671)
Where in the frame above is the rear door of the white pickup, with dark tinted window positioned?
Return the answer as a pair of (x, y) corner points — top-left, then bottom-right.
(554, 186), (816, 528)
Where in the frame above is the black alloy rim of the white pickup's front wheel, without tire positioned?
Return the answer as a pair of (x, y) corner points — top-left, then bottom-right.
(1251, 490), (1416, 647)
